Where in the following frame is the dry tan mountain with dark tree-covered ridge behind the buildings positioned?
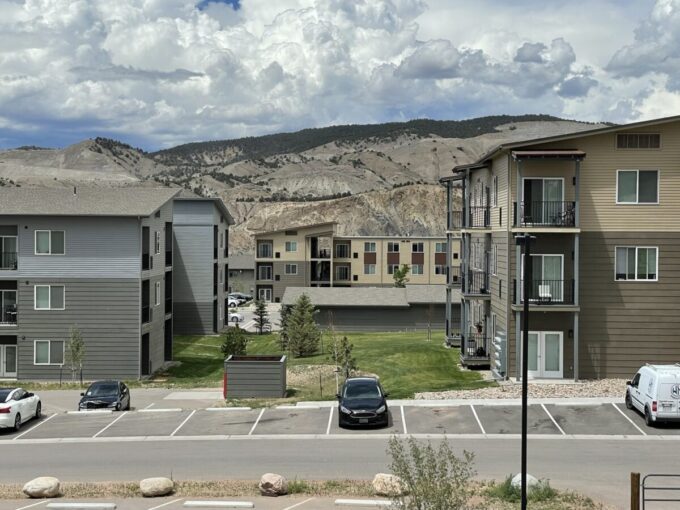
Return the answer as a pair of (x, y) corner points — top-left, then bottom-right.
(0, 115), (603, 253)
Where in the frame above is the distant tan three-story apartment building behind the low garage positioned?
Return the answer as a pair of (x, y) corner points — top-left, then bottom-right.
(255, 223), (459, 302)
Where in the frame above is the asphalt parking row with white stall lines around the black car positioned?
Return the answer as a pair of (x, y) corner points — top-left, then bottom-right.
(0, 403), (680, 441)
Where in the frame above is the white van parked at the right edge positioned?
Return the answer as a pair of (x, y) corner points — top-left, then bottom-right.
(626, 364), (680, 427)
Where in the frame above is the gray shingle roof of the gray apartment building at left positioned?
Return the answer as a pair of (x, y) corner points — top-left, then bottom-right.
(0, 186), (179, 216)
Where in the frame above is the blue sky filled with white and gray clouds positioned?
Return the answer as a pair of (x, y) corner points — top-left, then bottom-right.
(0, 0), (680, 151)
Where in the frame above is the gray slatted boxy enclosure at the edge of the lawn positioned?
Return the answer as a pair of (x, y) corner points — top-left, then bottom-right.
(223, 355), (286, 398)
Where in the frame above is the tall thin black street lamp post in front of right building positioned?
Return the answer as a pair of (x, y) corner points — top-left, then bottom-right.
(515, 234), (536, 510)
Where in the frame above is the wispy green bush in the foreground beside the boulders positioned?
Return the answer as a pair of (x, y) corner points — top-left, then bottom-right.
(387, 437), (475, 510)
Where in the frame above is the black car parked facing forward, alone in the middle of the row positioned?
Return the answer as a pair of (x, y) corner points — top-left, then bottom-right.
(336, 377), (389, 428)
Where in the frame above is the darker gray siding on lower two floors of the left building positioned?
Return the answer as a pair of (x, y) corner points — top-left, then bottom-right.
(17, 278), (140, 380)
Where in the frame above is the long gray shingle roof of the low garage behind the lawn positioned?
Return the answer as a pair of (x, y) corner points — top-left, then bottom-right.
(281, 285), (460, 308)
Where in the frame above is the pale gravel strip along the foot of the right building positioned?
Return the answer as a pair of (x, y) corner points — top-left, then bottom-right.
(415, 379), (626, 400)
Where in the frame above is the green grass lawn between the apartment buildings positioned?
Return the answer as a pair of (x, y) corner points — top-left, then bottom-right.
(158, 332), (489, 400)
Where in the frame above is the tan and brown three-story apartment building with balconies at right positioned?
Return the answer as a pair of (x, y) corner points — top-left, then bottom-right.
(442, 113), (680, 379)
